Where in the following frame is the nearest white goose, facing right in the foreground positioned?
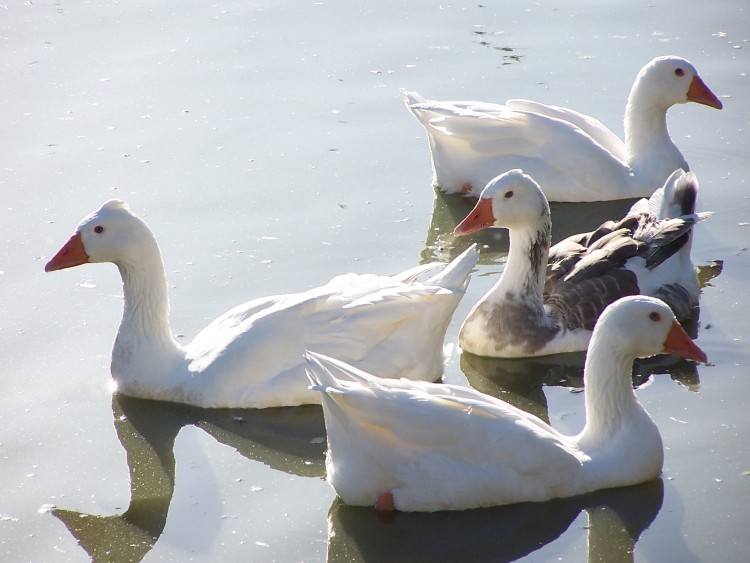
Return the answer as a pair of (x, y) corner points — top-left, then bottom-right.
(305, 295), (707, 512)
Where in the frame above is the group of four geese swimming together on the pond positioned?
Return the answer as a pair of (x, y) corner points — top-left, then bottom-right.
(45, 56), (722, 511)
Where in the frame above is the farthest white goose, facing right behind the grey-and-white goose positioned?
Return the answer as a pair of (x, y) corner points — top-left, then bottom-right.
(402, 56), (722, 202)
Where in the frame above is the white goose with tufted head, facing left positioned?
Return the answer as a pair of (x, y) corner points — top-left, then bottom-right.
(45, 200), (478, 408)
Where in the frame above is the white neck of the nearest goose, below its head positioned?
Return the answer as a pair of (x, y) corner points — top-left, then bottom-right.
(579, 330), (648, 450)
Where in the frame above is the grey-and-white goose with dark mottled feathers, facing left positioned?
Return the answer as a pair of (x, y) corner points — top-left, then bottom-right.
(453, 169), (710, 358)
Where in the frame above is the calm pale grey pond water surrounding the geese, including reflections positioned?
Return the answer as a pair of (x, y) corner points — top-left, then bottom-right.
(0, 0), (750, 562)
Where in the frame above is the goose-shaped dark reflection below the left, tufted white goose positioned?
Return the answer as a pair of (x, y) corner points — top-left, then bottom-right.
(52, 394), (326, 561)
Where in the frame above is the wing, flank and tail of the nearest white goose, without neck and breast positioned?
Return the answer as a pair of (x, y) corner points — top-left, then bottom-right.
(307, 353), (587, 510)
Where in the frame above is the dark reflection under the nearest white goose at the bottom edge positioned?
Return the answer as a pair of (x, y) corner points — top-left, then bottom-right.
(328, 479), (664, 562)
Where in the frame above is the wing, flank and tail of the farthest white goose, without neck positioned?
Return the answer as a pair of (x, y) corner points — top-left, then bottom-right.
(410, 96), (632, 201)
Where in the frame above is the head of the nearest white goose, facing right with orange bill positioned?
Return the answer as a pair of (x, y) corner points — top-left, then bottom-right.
(591, 295), (707, 363)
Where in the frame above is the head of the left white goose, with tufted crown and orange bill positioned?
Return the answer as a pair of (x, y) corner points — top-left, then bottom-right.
(44, 199), (155, 272)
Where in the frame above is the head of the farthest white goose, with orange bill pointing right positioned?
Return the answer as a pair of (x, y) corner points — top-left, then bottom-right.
(630, 56), (723, 110)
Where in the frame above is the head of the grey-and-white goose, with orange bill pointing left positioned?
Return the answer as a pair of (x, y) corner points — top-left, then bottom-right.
(453, 169), (550, 236)
